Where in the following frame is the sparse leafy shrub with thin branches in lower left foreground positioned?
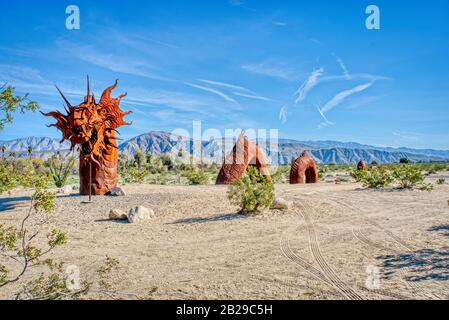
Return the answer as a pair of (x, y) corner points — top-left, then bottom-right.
(0, 165), (155, 300)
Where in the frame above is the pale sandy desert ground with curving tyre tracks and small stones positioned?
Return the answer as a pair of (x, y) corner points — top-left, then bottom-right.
(0, 173), (449, 299)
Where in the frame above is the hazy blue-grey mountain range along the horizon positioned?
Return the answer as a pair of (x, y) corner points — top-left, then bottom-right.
(0, 131), (449, 164)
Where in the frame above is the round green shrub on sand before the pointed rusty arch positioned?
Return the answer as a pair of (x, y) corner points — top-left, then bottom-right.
(228, 166), (274, 214)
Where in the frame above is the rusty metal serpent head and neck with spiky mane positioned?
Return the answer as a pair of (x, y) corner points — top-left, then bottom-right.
(42, 77), (131, 195)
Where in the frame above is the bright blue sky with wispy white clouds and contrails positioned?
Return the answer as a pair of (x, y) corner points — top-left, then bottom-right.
(0, 0), (449, 149)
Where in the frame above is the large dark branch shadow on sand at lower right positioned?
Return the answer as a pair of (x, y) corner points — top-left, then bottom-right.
(378, 249), (449, 281)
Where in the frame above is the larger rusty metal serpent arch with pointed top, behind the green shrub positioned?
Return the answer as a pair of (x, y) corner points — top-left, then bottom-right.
(215, 133), (271, 184)
